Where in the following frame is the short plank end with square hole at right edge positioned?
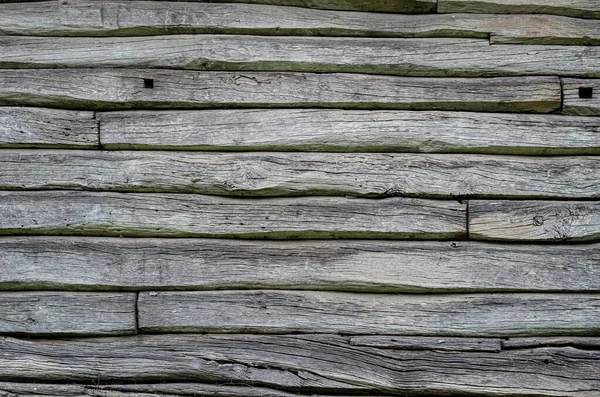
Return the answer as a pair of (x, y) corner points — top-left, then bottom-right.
(562, 77), (600, 114)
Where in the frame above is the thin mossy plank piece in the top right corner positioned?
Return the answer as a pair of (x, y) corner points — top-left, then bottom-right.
(437, 0), (600, 18)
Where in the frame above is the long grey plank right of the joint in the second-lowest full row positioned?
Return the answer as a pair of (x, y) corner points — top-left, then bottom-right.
(138, 290), (600, 336)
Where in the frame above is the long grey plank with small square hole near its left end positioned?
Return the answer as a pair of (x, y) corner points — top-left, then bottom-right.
(0, 69), (561, 113)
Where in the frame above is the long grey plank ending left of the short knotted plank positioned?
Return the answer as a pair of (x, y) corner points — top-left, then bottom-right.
(0, 191), (466, 239)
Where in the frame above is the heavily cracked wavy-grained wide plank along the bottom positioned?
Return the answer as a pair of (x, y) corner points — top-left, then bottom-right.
(0, 334), (600, 397)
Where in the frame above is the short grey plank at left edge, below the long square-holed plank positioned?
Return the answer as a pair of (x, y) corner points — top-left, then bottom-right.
(0, 107), (99, 149)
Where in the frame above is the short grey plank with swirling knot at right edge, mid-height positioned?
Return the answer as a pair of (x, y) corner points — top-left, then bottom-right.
(469, 201), (600, 242)
